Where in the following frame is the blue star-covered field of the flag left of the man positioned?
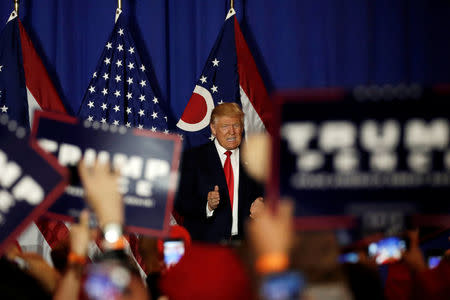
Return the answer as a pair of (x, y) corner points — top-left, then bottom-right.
(78, 12), (169, 133)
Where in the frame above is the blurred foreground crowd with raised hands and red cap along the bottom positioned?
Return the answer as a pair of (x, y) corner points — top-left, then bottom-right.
(0, 158), (450, 300)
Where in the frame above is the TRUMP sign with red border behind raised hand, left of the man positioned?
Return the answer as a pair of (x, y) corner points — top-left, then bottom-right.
(31, 112), (181, 236)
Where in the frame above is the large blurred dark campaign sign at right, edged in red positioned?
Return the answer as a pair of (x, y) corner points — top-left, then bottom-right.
(269, 89), (450, 230)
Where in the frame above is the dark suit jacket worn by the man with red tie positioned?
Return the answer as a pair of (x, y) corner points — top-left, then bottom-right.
(175, 142), (264, 242)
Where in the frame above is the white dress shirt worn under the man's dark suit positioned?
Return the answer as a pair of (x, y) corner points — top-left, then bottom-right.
(206, 139), (239, 235)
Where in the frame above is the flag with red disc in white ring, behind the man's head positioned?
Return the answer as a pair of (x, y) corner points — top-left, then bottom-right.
(177, 9), (272, 147)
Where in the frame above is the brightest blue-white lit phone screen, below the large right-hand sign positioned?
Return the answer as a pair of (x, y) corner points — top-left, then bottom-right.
(368, 237), (407, 265)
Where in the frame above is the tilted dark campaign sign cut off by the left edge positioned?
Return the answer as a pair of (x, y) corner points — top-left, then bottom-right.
(0, 115), (67, 254)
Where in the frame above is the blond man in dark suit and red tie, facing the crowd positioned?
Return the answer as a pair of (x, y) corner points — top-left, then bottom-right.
(175, 103), (264, 242)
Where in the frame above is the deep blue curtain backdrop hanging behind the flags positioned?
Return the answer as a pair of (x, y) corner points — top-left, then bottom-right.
(0, 0), (450, 127)
